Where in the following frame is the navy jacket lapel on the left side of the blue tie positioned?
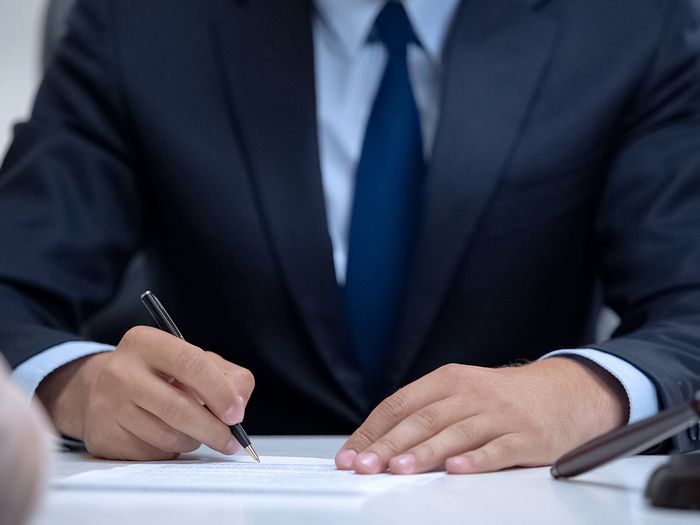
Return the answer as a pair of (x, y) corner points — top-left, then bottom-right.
(208, 0), (363, 410)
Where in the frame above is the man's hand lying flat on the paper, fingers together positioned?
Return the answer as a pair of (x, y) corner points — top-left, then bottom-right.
(335, 357), (628, 474)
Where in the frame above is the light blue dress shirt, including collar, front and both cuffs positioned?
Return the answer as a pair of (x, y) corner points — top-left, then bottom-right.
(13, 0), (658, 422)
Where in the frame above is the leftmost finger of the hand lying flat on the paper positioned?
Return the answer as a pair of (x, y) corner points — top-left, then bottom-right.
(335, 371), (449, 470)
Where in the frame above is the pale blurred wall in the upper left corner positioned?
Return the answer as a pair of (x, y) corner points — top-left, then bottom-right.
(0, 0), (46, 157)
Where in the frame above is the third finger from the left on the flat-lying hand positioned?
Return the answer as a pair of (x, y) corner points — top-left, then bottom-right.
(389, 415), (501, 474)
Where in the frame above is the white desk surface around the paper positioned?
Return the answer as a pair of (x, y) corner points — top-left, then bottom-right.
(32, 436), (700, 525)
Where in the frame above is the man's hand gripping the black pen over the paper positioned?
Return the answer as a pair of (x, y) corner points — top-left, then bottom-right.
(37, 326), (255, 460)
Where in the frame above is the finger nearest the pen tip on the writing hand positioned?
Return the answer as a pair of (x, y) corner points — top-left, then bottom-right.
(129, 364), (240, 454)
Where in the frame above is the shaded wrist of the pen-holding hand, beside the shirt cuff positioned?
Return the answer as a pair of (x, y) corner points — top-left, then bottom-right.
(36, 353), (111, 439)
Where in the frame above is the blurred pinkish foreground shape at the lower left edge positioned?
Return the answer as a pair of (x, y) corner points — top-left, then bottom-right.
(0, 356), (48, 525)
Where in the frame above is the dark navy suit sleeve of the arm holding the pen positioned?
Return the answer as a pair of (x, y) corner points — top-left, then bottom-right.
(0, 0), (141, 368)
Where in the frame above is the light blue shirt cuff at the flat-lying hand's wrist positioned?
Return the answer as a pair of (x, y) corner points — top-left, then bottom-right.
(540, 348), (659, 423)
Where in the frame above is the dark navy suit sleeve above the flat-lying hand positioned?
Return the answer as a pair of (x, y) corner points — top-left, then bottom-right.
(591, 0), (700, 451)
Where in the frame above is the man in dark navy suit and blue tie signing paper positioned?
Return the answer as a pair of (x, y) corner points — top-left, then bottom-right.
(0, 0), (700, 473)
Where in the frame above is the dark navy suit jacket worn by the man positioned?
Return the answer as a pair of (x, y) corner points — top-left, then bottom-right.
(0, 0), (700, 450)
